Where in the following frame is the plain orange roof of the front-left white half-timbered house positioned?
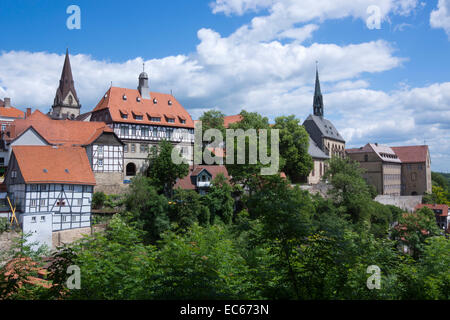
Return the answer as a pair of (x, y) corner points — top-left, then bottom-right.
(12, 146), (95, 185)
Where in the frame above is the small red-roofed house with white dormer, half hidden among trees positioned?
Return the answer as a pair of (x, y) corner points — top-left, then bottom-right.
(174, 165), (230, 194)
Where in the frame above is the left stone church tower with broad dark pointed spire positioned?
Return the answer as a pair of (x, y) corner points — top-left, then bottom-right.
(49, 50), (81, 119)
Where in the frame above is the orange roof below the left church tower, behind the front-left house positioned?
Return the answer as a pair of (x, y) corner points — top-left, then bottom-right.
(11, 111), (113, 145)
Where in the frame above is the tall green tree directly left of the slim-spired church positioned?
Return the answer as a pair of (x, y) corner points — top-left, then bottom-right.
(273, 115), (313, 182)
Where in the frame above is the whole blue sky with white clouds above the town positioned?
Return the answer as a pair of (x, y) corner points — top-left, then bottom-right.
(0, 0), (450, 172)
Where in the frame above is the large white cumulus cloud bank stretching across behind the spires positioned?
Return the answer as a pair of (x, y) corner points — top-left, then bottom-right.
(0, 0), (450, 170)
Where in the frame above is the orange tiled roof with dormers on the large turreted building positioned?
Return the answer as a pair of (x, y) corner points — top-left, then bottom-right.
(92, 87), (194, 128)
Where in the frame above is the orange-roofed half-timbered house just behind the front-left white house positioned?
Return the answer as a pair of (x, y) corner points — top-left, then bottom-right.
(5, 110), (124, 193)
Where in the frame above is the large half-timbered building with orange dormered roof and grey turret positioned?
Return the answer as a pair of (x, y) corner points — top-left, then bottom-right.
(90, 72), (194, 181)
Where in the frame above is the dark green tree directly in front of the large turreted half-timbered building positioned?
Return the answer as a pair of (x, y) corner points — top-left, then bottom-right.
(147, 140), (189, 197)
